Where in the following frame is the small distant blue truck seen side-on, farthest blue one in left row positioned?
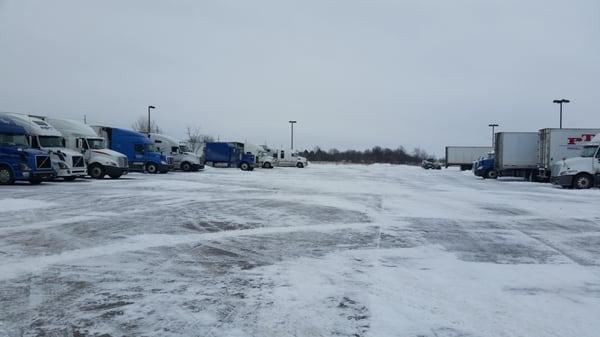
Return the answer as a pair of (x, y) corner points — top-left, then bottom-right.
(204, 142), (255, 171)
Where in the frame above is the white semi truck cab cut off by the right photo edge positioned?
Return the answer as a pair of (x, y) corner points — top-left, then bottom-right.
(551, 134), (600, 189)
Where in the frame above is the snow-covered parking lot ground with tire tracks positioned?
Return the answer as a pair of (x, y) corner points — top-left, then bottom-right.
(0, 165), (600, 337)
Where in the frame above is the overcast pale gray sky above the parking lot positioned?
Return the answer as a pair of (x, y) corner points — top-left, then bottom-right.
(0, 0), (600, 155)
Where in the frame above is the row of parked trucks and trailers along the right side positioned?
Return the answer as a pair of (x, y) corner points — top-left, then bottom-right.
(446, 128), (600, 189)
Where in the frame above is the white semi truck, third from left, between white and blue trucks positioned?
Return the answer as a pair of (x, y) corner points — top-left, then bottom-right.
(43, 117), (129, 179)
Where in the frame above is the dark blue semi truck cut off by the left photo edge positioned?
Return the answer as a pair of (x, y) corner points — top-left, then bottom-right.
(0, 118), (56, 185)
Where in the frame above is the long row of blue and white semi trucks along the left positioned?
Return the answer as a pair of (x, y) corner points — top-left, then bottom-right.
(0, 112), (308, 184)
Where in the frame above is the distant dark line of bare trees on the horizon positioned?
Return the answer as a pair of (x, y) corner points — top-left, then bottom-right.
(300, 146), (435, 165)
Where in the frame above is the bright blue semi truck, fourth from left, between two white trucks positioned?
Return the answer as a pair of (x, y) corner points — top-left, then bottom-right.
(92, 125), (172, 174)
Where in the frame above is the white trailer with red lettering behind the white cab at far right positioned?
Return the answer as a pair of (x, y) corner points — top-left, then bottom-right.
(538, 128), (600, 181)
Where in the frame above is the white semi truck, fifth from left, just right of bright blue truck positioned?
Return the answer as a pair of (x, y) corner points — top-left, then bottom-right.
(148, 133), (204, 171)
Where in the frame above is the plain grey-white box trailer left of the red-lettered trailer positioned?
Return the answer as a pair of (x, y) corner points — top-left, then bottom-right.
(494, 132), (539, 180)
